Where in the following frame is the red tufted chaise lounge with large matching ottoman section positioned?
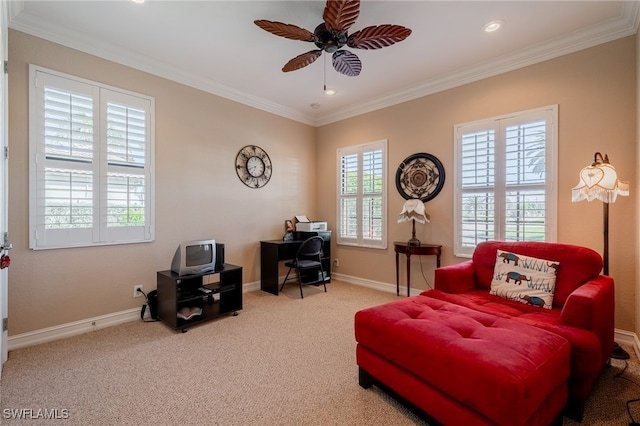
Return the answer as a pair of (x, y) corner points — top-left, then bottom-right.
(355, 241), (614, 425)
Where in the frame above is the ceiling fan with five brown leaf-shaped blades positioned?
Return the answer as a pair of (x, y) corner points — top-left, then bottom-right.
(254, 0), (411, 77)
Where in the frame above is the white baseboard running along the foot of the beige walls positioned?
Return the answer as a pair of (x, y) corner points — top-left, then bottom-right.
(8, 272), (640, 358)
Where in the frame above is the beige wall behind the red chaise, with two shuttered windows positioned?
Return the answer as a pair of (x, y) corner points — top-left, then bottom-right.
(317, 36), (638, 331)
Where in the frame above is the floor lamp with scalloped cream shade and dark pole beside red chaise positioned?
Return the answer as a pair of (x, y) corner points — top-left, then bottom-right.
(571, 152), (629, 359)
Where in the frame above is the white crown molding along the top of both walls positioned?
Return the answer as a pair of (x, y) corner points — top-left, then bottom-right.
(9, 1), (640, 127)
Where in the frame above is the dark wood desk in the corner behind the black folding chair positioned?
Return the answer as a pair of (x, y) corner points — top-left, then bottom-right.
(260, 231), (331, 296)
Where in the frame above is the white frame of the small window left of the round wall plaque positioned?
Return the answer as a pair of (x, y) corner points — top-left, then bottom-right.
(336, 139), (388, 249)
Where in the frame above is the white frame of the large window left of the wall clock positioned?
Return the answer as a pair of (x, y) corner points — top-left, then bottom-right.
(29, 64), (155, 250)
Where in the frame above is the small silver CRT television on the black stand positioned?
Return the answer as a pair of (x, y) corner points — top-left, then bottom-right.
(171, 240), (216, 275)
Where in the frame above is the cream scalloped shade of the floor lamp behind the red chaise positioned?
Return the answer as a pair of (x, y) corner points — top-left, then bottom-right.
(571, 153), (629, 203)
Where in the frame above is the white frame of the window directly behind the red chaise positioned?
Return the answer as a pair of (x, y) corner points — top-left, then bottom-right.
(453, 105), (558, 257)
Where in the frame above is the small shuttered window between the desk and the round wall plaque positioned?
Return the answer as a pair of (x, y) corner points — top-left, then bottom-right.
(337, 140), (387, 248)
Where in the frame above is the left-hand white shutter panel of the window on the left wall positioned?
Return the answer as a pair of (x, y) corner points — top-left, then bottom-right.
(30, 73), (99, 247)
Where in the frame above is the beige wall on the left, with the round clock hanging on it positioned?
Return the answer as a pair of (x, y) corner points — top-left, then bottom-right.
(9, 31), (316, 335)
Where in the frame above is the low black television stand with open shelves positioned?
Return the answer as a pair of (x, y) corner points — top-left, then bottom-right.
(157, 263), (242, 333)
